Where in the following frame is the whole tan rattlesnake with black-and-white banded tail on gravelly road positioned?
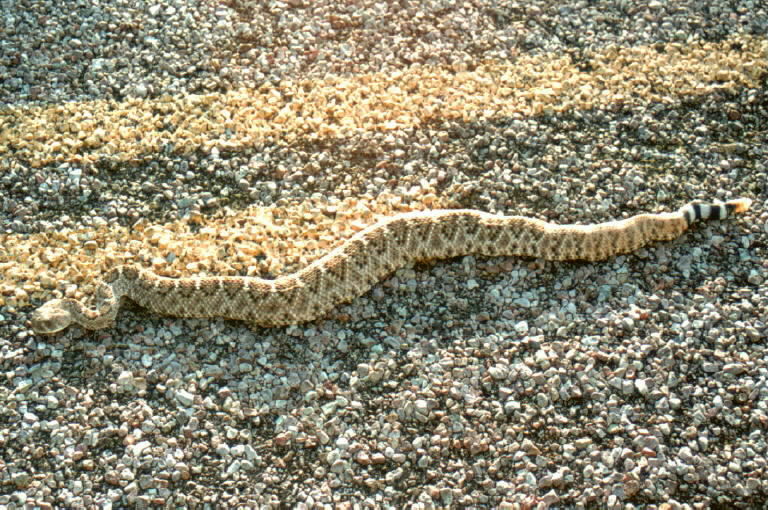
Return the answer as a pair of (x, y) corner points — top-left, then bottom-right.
(31, 198), (752, 334)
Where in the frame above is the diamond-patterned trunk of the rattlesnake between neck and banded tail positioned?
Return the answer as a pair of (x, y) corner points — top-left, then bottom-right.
(115, 211), (696, 325)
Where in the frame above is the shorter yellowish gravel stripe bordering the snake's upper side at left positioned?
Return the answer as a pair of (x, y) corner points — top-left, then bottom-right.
(0, 192), (436, 307)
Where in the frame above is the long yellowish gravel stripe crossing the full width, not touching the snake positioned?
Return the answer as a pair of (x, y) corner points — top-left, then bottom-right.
(0, 36), (768, 170)
